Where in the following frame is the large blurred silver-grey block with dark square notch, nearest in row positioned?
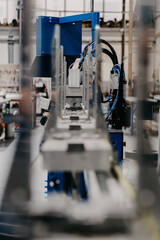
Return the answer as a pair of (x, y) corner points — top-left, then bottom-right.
(42, 131), (113, 172)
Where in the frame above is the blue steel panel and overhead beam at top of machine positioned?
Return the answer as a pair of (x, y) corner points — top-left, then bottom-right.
(36, 12), (99, 56)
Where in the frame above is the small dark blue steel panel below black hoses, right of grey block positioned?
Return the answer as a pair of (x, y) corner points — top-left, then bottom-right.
(109, 131), (123, 167)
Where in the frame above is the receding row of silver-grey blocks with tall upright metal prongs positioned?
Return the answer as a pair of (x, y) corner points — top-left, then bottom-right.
(42, 24), (113, 172)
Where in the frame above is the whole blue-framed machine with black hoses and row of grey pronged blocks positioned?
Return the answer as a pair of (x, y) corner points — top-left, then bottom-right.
(29, 13), (127, 198)
